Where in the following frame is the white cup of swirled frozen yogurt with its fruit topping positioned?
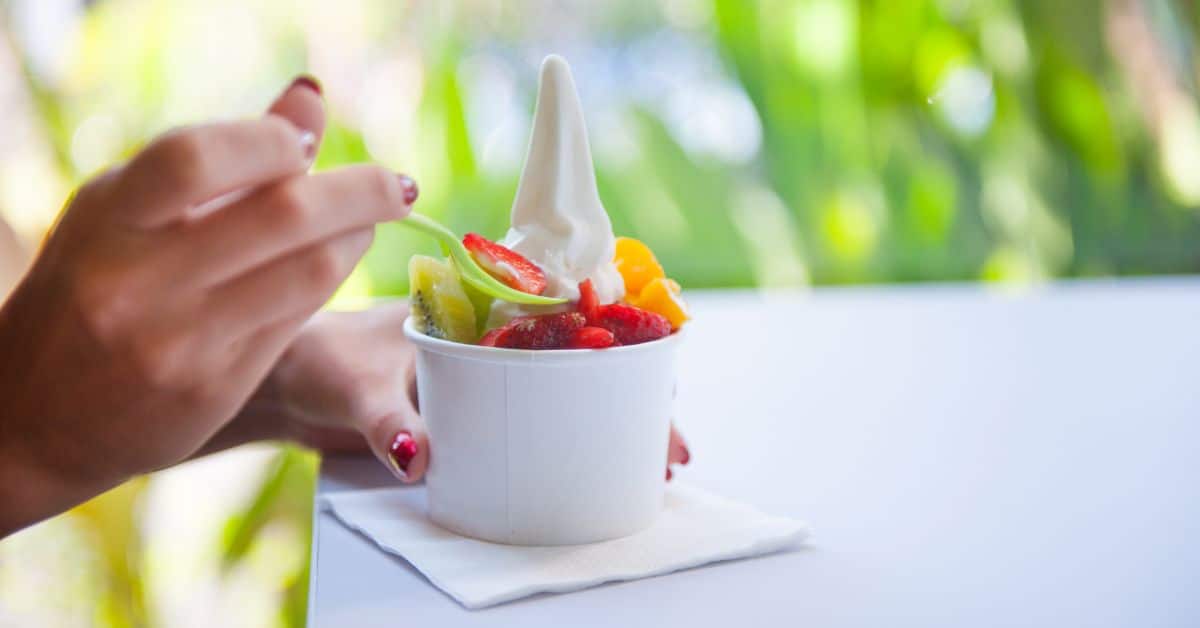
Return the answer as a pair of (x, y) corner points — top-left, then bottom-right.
(404, 56), (688, 545)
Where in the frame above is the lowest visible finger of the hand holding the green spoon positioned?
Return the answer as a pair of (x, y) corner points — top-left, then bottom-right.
(206, 227), (374, 337)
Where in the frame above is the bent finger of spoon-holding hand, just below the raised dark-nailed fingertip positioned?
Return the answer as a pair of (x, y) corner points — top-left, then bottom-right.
(119, 115), (316, 228)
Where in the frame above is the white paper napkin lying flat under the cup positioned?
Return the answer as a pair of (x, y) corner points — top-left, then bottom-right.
(322, 482), (808, 609)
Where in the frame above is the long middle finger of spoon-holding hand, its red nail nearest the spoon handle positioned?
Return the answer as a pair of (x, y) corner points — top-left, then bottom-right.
(161, 166), (415, 286)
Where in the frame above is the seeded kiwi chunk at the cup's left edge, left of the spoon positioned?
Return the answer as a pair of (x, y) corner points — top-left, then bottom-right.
(408, 255), (479, 343)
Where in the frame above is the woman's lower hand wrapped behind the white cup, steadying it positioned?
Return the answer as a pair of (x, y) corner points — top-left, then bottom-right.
(204, 303), (690, 483)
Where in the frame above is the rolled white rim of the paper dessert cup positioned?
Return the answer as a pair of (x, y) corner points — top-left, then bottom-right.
(404, 316), (685, 364)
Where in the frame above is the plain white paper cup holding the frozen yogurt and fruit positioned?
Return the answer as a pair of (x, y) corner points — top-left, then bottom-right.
(404, 318), (680, 545)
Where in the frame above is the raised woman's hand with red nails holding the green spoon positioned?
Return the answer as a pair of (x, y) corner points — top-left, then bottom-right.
(0, 79), (416, 536)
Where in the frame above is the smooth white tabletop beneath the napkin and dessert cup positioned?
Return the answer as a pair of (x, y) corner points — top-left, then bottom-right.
(310, 279), (1200, 628)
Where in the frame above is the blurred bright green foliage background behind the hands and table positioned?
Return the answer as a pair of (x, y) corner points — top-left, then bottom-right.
(0, 0), (1200, 626)
